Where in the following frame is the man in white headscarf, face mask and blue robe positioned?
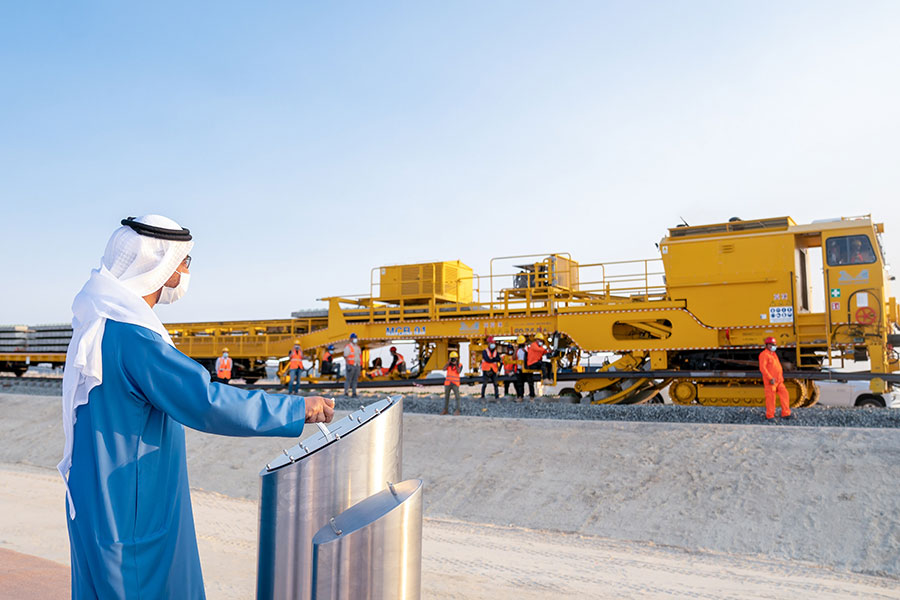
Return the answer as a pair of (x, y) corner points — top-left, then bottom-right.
(59, 215), (333, 599)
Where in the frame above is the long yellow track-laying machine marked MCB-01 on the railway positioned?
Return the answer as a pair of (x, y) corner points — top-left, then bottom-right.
(0, 216), (900, 406)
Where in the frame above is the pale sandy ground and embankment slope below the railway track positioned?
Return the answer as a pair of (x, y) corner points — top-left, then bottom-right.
(0, 394), (900, 599)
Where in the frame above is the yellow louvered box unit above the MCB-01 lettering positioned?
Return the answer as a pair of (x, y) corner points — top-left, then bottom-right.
(375, 260), (472, 304)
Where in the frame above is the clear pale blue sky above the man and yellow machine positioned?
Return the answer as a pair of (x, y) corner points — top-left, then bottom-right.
(0, 0), (900, 324)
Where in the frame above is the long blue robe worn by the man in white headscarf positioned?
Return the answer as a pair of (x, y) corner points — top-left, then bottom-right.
(66, 321), (306, 600)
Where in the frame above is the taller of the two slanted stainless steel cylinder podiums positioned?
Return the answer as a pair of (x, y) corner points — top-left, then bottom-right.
(256, 396), (406, 600)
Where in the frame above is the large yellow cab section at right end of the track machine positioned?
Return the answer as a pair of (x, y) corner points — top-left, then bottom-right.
(660, 216), (900, 380)
